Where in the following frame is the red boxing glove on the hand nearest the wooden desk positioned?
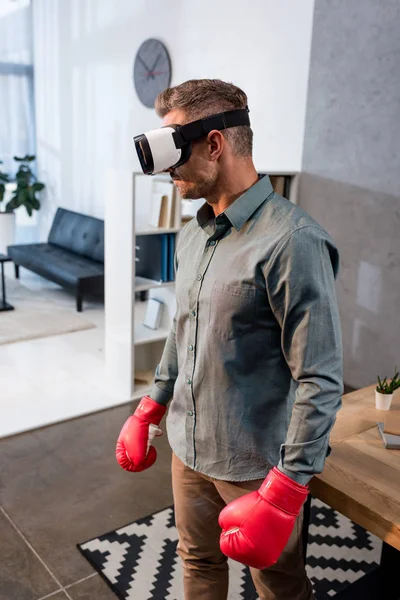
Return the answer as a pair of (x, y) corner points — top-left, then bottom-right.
(219, 467), (308, 569)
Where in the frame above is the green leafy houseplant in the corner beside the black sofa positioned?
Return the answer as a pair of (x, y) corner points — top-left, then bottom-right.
(6, 154), (45, 217)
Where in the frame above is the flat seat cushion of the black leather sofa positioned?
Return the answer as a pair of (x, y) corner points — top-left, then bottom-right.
(8, 243), (104, 287)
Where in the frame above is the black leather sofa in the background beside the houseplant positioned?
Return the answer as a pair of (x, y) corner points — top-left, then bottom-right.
(8, 208), (104, 312)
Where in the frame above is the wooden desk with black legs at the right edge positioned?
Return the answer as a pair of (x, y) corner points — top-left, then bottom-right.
(304, 385), (400, 600)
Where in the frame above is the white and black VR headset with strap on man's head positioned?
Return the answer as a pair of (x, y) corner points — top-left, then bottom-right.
(133, 106), (250, 175)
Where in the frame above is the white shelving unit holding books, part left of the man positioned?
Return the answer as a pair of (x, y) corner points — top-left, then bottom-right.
(105, 170), (181, 402)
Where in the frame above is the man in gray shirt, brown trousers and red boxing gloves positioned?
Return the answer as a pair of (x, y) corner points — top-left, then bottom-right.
(117, 80), (343, 600)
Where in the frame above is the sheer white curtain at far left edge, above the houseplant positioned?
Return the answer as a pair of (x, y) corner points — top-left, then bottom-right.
(0, 0), (35, 176)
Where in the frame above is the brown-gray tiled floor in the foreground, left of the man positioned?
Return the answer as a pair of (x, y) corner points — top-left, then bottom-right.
(0, 403), (172, 600)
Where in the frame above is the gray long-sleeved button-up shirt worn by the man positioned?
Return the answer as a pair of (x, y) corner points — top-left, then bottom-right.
(151, 176), (343, 484)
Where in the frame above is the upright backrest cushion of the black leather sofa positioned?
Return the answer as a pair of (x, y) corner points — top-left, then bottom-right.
(47, 208), (104, 263)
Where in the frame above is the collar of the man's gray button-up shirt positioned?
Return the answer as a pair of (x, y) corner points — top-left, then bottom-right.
(197, 175), (274, 231)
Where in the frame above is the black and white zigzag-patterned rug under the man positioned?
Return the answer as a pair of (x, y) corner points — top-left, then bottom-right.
(77, 498), (382, 600)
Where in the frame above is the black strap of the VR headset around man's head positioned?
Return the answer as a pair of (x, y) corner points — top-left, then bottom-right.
(172, 106), (250, 148)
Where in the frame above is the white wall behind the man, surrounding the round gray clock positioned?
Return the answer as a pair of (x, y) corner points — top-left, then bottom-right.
(34, 0), (314, 237)
